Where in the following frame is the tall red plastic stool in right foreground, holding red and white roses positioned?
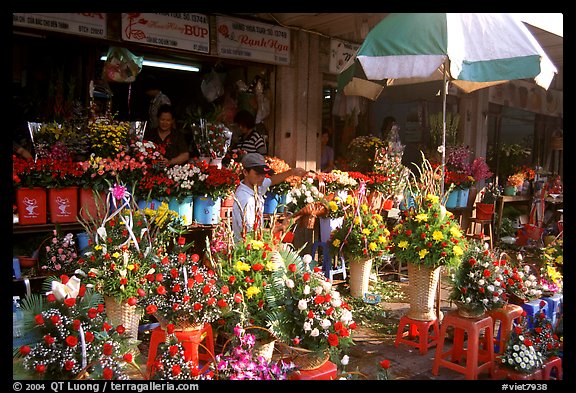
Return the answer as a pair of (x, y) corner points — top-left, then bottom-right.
(432, 311), (494, 379)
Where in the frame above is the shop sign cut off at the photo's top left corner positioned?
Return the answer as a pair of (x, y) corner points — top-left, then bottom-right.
(12, 12), (108, 38)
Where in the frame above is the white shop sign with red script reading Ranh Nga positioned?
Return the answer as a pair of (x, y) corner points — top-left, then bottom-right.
(216, 16), (290, 65)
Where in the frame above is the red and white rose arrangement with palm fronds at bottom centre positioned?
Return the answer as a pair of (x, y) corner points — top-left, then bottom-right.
(266, 247), (356, 362)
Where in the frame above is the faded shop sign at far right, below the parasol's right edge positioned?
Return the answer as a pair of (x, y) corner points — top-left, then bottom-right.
(488, 81), (563, 116)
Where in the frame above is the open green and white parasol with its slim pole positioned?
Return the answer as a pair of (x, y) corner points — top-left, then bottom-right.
(339, 13), (558, 194)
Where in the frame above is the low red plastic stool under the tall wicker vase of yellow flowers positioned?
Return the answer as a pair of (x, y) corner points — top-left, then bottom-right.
(394, 315), (439, 355)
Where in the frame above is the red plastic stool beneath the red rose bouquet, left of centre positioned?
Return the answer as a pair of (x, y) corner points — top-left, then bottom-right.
(146, 323), (214, 373)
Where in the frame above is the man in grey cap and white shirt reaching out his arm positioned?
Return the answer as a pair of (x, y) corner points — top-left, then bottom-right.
(232, 153), (307, 241)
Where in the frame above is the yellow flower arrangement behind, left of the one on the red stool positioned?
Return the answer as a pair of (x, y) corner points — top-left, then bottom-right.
(329, 189), (390, 258)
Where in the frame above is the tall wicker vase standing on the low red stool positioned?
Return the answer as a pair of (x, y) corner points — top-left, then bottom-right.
(407, 262), (441, 321)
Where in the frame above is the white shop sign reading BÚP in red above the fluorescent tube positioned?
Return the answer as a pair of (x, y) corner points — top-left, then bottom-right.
(122, 12), (210, 53)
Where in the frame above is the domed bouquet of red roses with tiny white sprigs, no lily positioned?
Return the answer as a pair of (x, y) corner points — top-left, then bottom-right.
(143, 237), (233, 330)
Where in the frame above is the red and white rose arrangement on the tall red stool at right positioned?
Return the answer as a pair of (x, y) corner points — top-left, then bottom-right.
(449, 245), (507, 315)
